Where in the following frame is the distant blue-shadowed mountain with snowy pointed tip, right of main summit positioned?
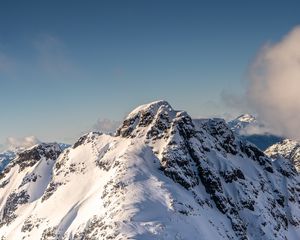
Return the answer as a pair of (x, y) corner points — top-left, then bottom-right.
(228, 114), (284, 151)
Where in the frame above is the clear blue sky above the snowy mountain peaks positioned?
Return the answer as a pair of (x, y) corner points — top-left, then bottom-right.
(0, 0), (300, 143)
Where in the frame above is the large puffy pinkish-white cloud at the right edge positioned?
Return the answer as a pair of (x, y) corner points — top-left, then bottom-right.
(246, 26), (300, 140)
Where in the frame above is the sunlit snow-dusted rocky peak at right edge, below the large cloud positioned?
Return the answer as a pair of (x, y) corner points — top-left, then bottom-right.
(265, 139), (300, 172)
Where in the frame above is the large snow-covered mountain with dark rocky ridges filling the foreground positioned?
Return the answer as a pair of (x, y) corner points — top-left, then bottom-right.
(0, 101), (300, 240)
